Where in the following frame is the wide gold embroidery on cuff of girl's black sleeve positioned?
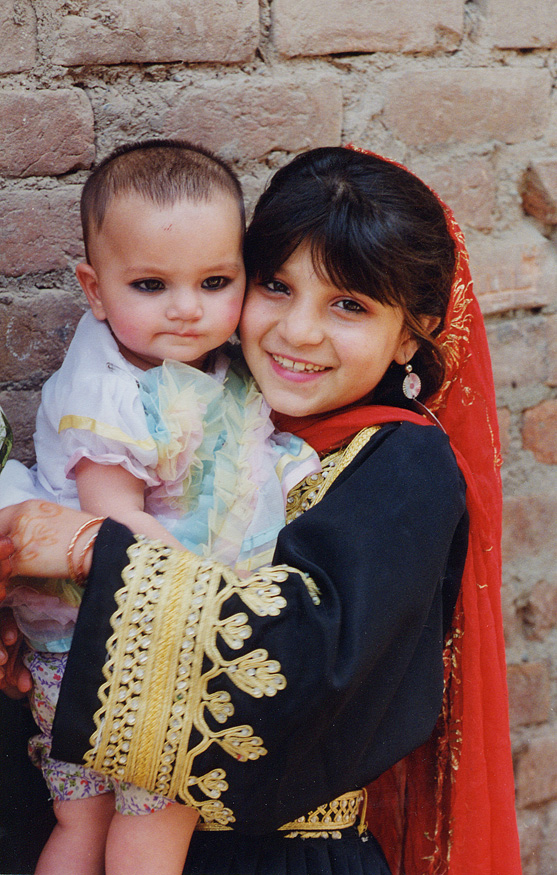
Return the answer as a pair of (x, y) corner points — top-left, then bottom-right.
(85, 538), (308, 824)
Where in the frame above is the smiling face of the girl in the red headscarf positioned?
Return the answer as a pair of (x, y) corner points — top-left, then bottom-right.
(240, 246), (417, 416)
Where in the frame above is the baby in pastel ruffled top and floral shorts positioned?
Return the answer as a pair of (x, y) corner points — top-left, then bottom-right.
(1, 141), (320, 875)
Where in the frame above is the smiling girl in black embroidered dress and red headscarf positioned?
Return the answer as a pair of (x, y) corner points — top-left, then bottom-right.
(0, 148), (520, 875)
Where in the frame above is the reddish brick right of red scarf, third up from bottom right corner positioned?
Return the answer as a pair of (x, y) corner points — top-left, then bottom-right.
(507, 662), (550, 728)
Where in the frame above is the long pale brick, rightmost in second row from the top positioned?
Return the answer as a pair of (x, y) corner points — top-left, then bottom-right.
(384, 67), (551, 145)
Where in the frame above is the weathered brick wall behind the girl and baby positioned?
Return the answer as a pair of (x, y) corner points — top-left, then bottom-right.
(0, 0), (557, 875)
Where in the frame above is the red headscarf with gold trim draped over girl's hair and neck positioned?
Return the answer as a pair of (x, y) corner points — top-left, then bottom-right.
(275, 150), (521, 875)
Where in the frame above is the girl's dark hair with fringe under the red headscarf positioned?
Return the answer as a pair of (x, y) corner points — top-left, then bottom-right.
(245, 147), (455, 406)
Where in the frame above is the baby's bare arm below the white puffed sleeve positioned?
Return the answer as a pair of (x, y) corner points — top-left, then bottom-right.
(75, 458), (184, 550)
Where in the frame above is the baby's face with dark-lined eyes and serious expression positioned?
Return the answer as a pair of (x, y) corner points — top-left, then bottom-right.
(77, 192), (245, 370)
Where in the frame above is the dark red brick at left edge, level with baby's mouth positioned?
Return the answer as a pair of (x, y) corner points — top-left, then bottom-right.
(0, 289), (86, 382)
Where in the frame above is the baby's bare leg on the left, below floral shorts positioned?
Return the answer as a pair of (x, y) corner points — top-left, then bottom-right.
(35, 793), (115, 875)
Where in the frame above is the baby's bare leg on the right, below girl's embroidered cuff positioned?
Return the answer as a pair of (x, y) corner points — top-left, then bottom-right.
(106, 803), (198, 875)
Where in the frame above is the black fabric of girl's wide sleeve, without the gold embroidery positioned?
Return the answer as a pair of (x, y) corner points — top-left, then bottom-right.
(53, 423), (467, 833)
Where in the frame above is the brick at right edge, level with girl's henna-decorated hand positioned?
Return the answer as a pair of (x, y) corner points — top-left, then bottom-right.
(503, 495), (557, 567)
